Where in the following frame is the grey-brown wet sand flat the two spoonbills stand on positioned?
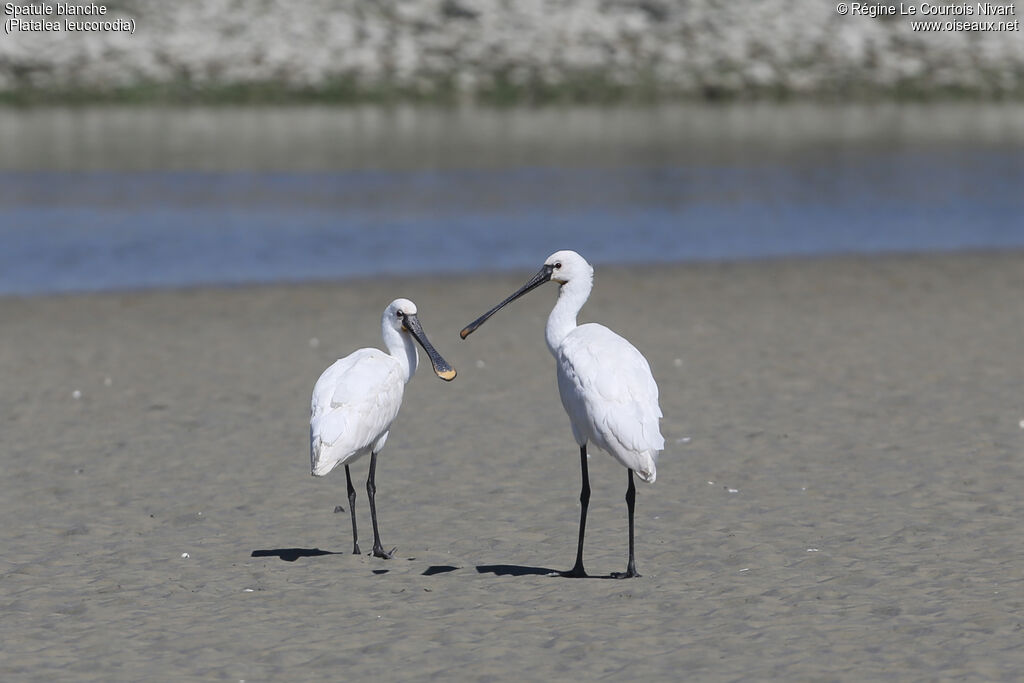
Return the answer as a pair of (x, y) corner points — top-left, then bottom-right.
(0, 253), (1024, 681)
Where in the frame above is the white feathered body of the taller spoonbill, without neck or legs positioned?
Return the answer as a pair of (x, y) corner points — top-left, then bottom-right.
(555, 323), (665, 483)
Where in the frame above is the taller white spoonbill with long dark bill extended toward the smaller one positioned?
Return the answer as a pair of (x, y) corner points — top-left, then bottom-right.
(460, 251), (665, 579)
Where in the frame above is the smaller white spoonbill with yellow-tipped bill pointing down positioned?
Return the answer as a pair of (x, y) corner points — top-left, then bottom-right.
(309, 299), (456, 559)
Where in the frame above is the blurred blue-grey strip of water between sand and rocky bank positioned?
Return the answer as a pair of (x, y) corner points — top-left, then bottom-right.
(0, 105), (1024, 294)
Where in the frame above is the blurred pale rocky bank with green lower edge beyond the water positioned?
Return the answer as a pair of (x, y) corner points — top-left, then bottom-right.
(0, 0), (1024, 103)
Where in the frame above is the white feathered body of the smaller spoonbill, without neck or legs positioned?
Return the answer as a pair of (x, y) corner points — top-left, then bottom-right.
(309, 348), (406, 476)
